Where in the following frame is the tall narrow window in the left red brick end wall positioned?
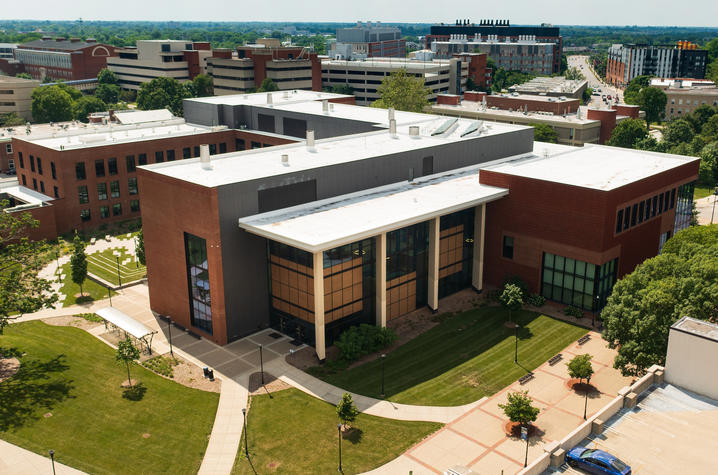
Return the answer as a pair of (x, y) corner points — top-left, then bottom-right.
(184, 233), (212, 334)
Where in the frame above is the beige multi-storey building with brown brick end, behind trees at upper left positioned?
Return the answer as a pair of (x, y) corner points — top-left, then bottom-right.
(107, 40), (212, 90)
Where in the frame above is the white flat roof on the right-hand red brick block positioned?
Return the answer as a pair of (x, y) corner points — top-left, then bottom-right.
(486, 142), (700, 191)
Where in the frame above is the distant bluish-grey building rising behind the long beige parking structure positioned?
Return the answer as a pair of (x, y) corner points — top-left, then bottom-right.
(329, 21), (406, 59)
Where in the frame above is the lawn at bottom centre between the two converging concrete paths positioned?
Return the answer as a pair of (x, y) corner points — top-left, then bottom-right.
(232, 388), (442, 474)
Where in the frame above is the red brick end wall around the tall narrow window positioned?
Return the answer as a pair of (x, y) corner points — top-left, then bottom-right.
(137, 169), (227, 345)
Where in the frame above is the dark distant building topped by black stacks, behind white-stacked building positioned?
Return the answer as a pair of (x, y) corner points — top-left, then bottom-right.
(426, 20), (563, 74)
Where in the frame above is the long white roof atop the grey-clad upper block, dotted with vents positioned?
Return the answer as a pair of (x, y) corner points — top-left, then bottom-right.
(142, 117), (526, 187)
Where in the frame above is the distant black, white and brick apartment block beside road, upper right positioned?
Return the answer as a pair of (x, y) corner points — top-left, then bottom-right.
(606, 41), (708, 87)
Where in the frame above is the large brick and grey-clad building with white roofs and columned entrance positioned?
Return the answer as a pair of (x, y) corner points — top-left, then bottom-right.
(139, 93), (699, 360)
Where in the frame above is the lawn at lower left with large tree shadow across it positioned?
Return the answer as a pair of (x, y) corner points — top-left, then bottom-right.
(0, 321), (219, 474)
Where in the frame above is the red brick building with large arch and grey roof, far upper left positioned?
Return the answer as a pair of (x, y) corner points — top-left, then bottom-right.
(14, 36), (115, 81)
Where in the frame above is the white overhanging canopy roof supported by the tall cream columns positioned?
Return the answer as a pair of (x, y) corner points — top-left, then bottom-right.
(239, 167), (508, 252)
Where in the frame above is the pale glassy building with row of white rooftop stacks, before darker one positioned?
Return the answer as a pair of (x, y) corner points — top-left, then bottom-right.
(431, 35), (556, 76)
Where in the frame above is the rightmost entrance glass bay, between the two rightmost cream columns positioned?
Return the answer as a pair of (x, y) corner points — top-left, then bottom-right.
(439, 208), (474, 298)
